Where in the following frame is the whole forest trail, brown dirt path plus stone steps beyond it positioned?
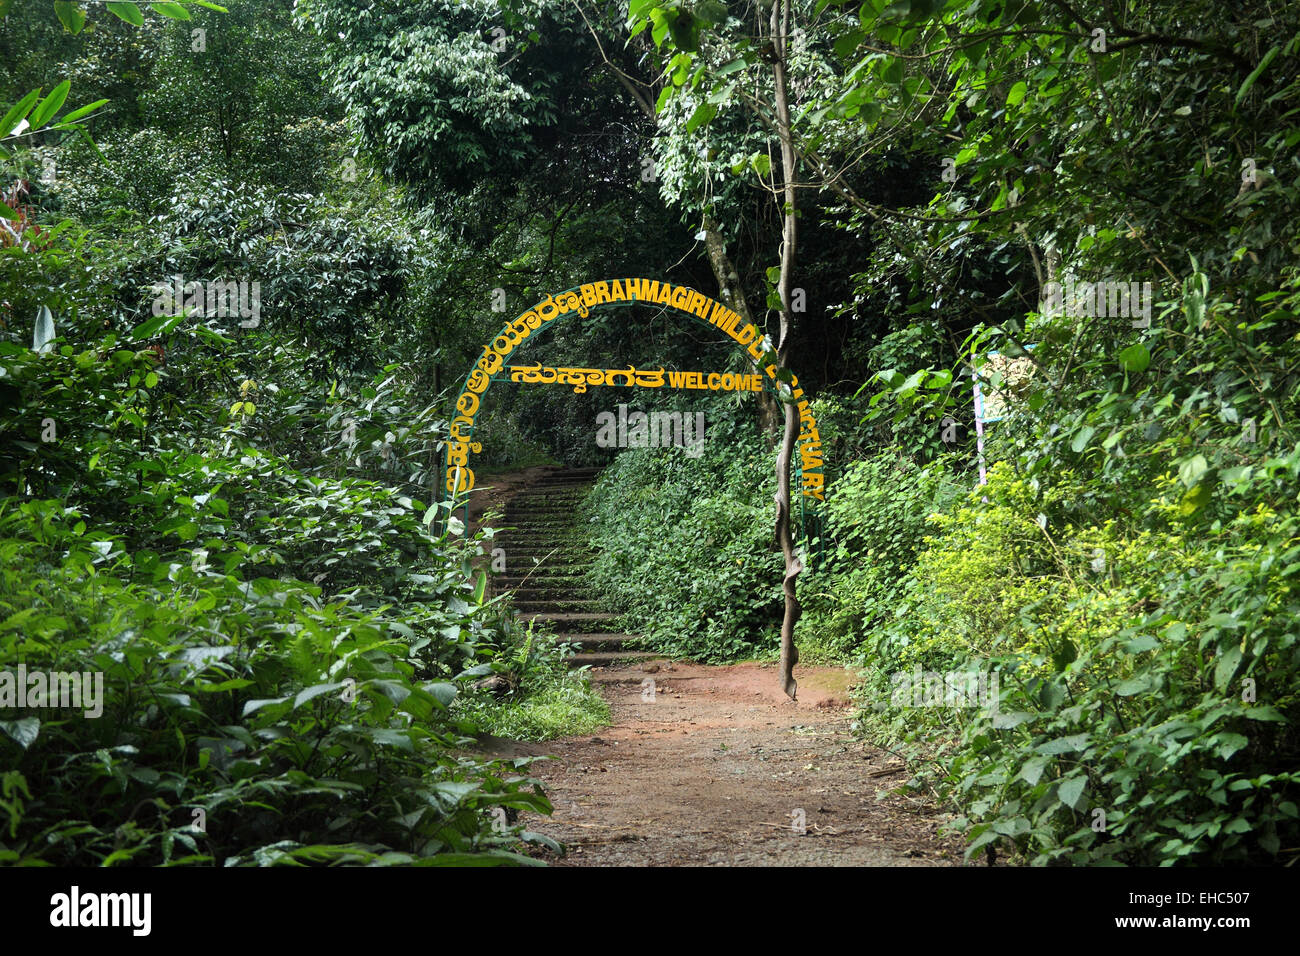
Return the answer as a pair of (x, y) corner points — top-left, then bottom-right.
(478, 470), (962, 866)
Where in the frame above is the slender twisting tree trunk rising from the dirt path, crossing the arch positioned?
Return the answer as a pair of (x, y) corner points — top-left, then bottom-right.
(771, 0), (803, 700)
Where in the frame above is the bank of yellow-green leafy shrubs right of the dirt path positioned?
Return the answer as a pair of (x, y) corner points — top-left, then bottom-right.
(865, 265), (1300, 864)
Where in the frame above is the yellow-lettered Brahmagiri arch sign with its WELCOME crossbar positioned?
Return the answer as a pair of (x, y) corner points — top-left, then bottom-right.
(443, 278), (826, 503)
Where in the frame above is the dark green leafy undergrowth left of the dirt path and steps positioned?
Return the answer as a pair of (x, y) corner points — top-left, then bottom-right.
(0, 317), (569, 865)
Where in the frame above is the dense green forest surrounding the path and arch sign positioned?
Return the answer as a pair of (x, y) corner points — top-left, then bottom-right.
(0, 0), (1300, 866)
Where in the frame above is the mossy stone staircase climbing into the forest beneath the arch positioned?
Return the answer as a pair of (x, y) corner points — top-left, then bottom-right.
(493, 468), (659, 667)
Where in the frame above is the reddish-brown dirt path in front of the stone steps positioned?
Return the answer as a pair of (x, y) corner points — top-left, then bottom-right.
(501, 662), (961, 866)
